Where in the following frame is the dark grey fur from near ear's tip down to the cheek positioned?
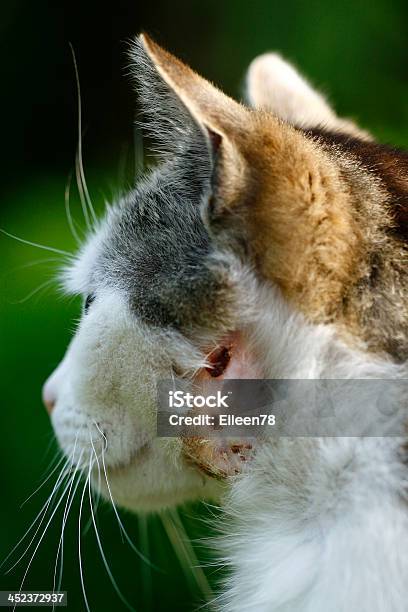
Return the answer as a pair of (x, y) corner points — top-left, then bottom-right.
(87, 42), (234, 329)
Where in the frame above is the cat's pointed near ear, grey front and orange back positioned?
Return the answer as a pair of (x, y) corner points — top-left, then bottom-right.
(132, 34), (251, 216)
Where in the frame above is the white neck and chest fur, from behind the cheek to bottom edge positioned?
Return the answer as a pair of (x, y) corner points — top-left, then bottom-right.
(215, 289), (408, 612)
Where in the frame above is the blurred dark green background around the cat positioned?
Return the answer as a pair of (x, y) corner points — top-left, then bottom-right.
(0, 0), (408, 611)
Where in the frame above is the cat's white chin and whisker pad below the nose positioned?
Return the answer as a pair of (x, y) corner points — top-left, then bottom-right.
(53, 409), (223, 513)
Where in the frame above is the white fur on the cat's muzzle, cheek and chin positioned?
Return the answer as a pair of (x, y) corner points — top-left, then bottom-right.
(48, 290), (222, 511)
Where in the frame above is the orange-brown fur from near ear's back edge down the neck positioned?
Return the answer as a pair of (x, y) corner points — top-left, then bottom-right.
(143, 36), (408, 358)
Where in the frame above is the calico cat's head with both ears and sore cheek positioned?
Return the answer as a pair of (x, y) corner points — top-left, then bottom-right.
(44, 36), (372, 510)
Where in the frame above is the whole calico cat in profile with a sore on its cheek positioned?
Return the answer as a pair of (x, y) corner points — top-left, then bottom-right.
(43, 35), (408, 612)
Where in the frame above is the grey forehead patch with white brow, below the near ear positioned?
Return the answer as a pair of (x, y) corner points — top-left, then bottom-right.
(64, 159), (231, 327)
